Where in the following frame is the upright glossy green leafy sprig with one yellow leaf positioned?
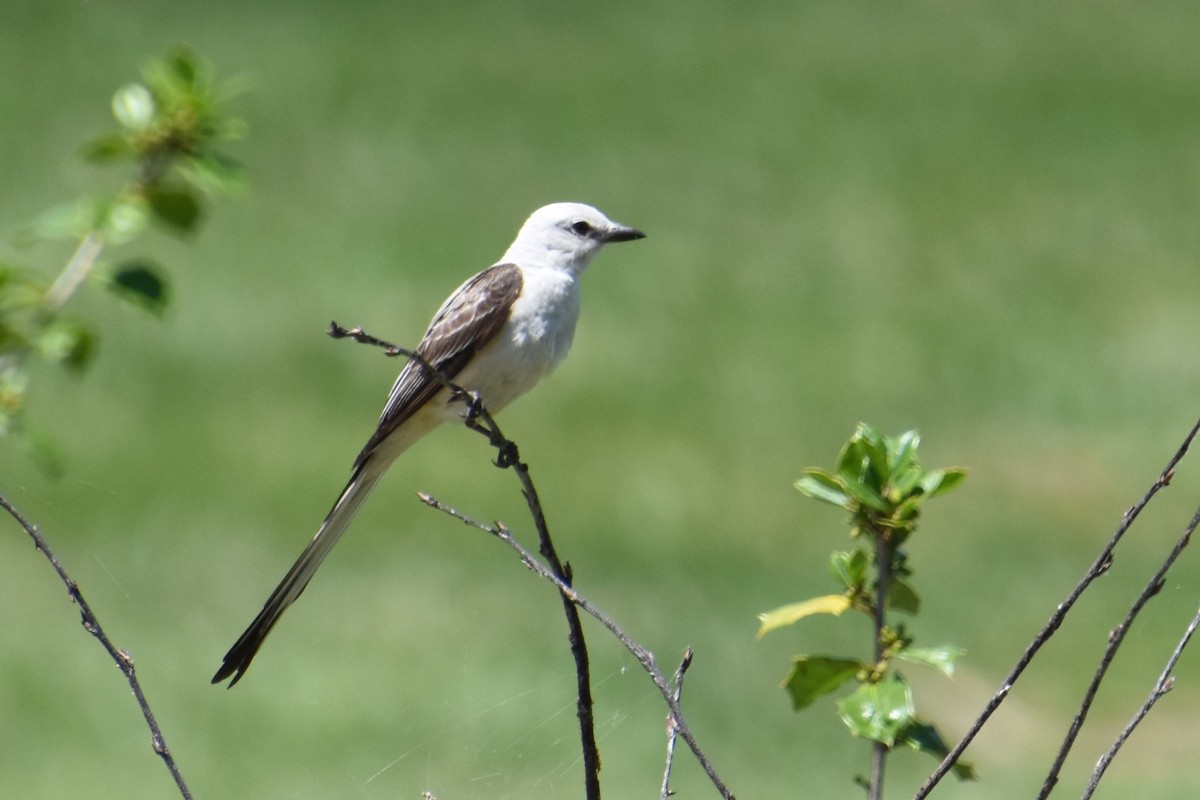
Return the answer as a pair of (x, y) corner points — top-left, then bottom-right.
(758, 423), (973, 800)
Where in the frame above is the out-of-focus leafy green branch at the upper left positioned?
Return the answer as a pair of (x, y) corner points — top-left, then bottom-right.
(0, 50), (245, 457)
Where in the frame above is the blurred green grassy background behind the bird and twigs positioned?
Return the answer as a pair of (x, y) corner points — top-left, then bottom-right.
(0, 0), (1200, 800)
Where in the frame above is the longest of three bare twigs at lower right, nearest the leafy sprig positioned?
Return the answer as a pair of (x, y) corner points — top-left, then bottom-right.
(913, 421), (1200, 800)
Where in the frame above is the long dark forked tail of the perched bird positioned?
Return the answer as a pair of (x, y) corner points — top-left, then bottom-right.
(212, 461), (383, 688)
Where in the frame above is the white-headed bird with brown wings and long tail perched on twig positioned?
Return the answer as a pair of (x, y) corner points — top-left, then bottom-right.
(212, 203), (646, 688)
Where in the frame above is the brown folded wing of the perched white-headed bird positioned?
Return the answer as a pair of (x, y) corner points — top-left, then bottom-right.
(354, 264), (522, 469)
